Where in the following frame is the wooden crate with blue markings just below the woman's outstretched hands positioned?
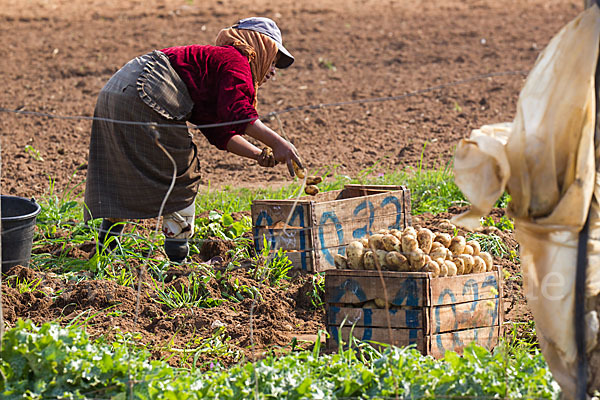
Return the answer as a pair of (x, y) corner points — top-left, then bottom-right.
(251, 185), (410, 272)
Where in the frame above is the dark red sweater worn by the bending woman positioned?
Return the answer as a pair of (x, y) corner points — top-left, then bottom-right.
(161, 45), (258, 150)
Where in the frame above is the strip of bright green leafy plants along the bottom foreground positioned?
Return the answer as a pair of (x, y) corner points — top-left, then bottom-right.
(0, 321), (559, 400)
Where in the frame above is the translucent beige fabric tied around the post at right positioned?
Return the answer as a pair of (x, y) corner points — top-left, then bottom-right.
(454, 6), (600, 398)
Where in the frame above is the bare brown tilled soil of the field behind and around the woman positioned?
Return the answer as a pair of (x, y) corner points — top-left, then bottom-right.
(0, 0), (583, 366)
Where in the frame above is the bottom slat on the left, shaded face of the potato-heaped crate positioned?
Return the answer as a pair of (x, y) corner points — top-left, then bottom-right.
(327, 325), (428, 352)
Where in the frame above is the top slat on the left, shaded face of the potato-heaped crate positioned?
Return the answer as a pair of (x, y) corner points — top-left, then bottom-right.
(325, 270), (430, 307)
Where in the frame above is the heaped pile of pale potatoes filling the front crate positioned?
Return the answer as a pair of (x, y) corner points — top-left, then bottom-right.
(334, 226), (493, 277)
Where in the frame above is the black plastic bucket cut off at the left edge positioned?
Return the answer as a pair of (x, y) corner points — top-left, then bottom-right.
(0, 195), (41, 272)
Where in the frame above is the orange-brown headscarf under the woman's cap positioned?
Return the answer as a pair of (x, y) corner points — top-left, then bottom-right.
(215, 28), (278, 107)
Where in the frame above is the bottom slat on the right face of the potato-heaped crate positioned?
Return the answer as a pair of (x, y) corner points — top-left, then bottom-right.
(426, 325), (502, 358)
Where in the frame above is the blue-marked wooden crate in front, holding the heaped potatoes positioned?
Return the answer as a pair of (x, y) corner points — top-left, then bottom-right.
(325, 267), (504, 358)
